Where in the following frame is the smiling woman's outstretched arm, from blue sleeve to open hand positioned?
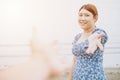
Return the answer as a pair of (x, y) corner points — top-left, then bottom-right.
(86, 29), (108, 54)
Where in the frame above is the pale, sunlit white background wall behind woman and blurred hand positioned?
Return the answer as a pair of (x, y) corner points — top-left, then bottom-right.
(0, 0), (120, 68)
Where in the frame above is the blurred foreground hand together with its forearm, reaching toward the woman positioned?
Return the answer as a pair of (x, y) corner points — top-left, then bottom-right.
(0, 27), (67, 80)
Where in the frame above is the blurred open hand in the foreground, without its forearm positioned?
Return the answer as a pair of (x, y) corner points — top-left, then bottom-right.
(31, 27), (69, 77)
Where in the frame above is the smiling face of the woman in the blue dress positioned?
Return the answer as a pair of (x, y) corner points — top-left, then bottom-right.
(78, 9), (96, 29)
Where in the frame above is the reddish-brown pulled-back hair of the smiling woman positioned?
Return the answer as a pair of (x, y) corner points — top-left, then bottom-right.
(79, 4), (98, 17)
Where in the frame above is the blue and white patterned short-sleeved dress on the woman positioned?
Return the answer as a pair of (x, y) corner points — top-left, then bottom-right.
(72, 28), (108, 80)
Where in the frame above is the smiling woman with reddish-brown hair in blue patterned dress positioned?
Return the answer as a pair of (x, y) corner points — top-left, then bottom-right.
(70, 4), (108, 80)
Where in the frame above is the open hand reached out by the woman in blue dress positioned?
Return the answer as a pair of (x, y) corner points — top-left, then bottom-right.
(86, 33), (105, 54)
